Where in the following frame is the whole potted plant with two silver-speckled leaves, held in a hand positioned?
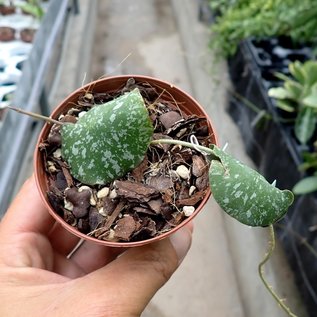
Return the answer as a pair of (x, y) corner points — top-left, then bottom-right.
(8, 76), (293, 311)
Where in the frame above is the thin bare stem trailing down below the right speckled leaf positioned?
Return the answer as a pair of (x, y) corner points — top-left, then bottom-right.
(258, 224), (297, 317)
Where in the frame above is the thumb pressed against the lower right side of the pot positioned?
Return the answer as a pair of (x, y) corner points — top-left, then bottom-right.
(77, 226), (192, 316)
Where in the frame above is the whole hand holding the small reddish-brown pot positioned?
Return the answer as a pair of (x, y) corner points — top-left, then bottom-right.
(0, 177), (192, 317)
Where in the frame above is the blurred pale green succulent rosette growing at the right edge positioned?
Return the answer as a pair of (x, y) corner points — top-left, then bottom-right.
(268, 60), (317, 144)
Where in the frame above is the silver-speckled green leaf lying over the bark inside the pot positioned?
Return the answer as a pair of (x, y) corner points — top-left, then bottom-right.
(61, 89), (153, 185)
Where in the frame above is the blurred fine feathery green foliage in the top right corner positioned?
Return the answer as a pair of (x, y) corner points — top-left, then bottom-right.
(210, 0), (317, 56)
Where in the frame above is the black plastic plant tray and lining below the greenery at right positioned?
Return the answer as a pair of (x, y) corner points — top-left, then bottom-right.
(227, 38), (317, 317)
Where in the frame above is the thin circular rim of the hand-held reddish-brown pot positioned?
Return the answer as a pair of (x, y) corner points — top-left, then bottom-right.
(34, 74), (218, 248)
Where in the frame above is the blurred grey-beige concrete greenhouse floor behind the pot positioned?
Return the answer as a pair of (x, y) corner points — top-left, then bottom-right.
(16, 0), (306, 317)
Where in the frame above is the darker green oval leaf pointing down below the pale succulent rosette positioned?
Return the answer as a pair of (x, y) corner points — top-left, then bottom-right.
(295, 107), (316, 144)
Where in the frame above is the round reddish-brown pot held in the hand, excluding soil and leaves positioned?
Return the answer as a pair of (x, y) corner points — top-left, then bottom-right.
(34, 75), (217, 247)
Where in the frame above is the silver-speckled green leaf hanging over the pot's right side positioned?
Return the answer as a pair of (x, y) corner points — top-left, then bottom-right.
(209, 147), (294, 227)
